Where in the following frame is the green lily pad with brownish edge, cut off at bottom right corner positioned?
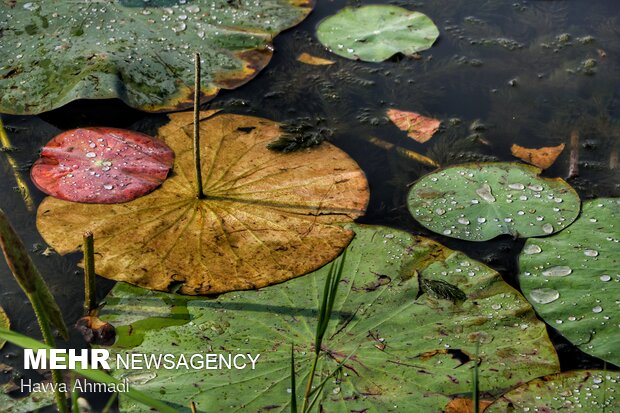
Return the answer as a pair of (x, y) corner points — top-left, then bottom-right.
(485, 370), (620, 413)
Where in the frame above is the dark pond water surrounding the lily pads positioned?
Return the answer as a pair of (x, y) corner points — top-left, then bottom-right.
(0, 0), (620, 408)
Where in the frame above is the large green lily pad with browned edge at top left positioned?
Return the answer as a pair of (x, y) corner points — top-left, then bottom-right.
(0, 0), (313, 114)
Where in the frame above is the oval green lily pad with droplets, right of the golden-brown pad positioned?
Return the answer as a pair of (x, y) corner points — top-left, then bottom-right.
(408, 162), (580, 241)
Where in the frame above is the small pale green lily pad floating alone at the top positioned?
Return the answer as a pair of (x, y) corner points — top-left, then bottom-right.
(316, 5), (439, 62)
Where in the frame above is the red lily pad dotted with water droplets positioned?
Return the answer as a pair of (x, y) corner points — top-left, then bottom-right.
(30, 128), (174, 204)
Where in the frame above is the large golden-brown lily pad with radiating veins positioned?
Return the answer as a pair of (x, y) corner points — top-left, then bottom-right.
(37, 111), (369, 294)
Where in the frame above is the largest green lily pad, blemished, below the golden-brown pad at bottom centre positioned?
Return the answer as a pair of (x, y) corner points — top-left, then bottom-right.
(101, 225), (559, 413)
